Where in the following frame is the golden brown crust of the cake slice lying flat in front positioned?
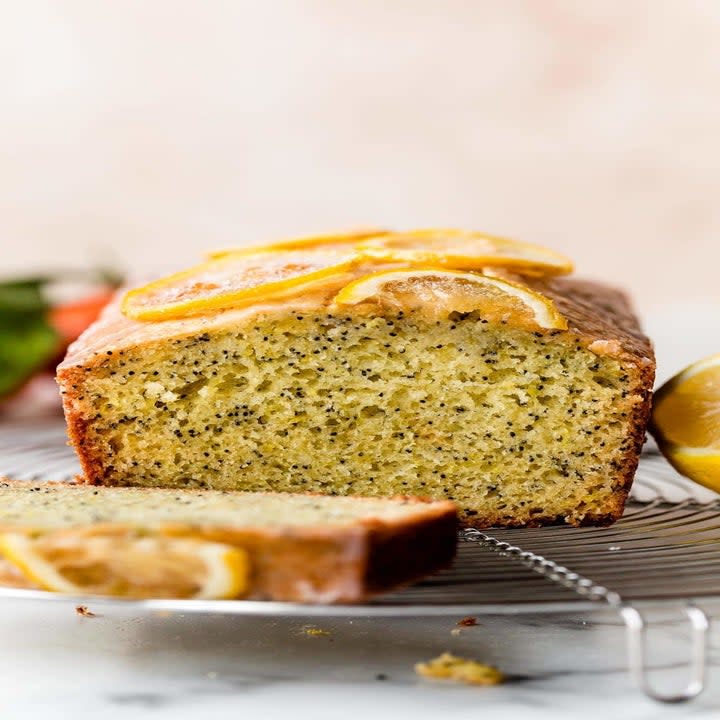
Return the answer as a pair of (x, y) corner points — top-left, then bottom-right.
(0, 478), (457, 603)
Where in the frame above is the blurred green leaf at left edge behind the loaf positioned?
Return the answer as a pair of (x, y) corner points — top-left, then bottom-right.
(0, 279), (58, 397)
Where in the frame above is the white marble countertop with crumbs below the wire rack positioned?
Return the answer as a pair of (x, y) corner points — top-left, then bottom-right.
(0, 600), (720, 720)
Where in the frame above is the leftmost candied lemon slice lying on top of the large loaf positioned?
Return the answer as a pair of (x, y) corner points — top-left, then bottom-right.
(122, 248), (357, 320)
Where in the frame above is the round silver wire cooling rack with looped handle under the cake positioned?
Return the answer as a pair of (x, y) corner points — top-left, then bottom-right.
(0, 419), (720, 702)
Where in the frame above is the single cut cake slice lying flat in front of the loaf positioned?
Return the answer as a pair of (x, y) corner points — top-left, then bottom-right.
(0, 480), (457, 603)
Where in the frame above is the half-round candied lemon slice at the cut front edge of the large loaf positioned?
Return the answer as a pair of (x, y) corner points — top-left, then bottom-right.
(335, 268), (567, 330)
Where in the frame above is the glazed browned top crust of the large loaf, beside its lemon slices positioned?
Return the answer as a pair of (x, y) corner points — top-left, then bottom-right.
(58, 277), (654, 373)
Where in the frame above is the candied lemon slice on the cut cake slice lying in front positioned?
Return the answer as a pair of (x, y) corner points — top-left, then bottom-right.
(0, 531), (249, 599)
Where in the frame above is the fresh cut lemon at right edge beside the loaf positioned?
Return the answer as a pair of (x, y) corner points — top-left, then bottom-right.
(650, 353), (720, 492)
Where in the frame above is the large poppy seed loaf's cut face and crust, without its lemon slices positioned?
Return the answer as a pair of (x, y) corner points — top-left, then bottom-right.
(59, 272), (654, 526)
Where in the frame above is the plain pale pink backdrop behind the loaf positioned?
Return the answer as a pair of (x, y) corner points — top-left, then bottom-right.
(0, 0), (720, 382)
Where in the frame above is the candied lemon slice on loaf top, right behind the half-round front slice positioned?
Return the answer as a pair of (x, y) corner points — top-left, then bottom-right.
(357, 229), (573, 275)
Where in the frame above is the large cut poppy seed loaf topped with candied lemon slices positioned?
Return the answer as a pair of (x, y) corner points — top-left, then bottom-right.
(58, 231), (654, 527)
